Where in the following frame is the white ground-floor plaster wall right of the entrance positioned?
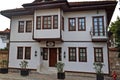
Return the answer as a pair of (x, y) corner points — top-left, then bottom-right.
(62, 42), (109, 73)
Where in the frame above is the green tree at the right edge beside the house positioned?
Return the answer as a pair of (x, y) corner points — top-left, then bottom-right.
(110, 17), (120, 57)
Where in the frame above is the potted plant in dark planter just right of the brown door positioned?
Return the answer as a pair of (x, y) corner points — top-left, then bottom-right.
(56, 62), (65, 79)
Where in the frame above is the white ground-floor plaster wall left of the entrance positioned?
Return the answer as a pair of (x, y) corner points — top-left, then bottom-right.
(9, 42), (41, 69)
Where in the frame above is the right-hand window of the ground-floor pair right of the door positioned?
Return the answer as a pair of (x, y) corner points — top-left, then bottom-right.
(79, 48), (87, 62)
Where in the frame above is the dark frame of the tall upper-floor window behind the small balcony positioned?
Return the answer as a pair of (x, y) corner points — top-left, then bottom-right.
(93, 16), (105, 36)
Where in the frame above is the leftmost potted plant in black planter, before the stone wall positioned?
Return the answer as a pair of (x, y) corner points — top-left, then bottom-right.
(0, 60), (8, 74)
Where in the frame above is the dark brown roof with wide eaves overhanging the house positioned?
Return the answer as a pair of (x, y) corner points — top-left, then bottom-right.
(0, 0), (117, 24)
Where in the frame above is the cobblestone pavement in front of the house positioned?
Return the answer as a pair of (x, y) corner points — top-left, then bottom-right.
(0, 72), (95, 80)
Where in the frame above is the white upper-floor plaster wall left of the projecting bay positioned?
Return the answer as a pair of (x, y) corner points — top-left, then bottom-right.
(10, 15), (33, 41)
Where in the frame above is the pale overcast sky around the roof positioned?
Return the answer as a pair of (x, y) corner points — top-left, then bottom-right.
(0, 0), (120, 31)
